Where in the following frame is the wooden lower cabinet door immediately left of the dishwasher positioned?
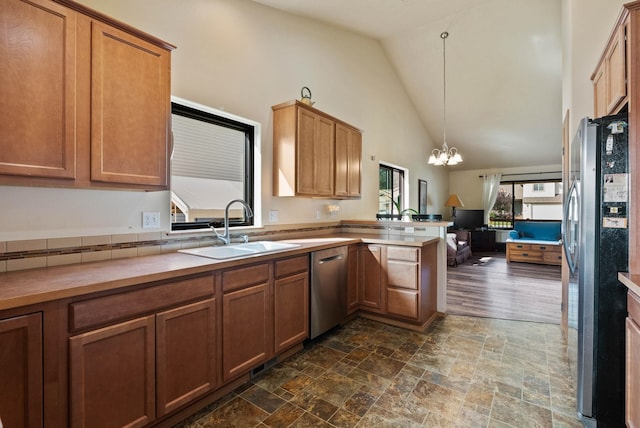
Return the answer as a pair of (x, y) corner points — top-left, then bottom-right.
(274, 272), (309, 353)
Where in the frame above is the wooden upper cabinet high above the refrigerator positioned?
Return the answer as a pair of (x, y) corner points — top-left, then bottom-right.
(591, 12), (629, 117)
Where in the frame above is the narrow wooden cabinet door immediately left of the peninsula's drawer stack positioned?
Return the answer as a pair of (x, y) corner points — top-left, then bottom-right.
(360, 245), (384, 312)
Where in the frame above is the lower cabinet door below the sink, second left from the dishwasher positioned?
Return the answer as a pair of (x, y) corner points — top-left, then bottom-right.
(222, 283), (273, 382)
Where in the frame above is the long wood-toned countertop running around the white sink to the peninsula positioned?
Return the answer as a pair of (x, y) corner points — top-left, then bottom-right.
(0, 233), (438, 310)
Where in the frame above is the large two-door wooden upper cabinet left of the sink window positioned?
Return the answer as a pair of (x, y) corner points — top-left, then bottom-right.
(0, 0), (174, 190)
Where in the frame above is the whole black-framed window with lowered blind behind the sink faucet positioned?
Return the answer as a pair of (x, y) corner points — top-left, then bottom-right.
(170, 97), (260, 230)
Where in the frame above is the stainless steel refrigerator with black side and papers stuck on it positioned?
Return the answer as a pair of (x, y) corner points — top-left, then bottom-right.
(563, 114), (629, 427)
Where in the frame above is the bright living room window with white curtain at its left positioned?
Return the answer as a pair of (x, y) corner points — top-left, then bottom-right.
(489, 180), (562, 229)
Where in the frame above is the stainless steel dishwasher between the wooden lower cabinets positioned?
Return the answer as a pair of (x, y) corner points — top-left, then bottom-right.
(310, 246), (348, 339)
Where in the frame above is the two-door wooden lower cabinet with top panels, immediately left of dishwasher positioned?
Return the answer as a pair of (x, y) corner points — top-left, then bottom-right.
(222, 254), (309, 382)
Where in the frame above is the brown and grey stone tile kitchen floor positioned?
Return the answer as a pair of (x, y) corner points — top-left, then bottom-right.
(178, 315), (582, 428)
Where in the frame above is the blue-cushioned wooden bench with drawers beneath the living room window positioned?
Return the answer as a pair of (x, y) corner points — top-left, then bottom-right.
(507, 220), (562, 265)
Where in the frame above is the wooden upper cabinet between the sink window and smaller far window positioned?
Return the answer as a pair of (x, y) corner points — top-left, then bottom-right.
(272, 101), (362, 199)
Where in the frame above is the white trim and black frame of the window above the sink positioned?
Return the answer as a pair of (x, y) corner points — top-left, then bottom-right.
(169, 96), (262, 232)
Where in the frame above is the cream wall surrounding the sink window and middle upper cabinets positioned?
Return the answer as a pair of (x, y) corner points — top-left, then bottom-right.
(0, 0), (448, 241)
